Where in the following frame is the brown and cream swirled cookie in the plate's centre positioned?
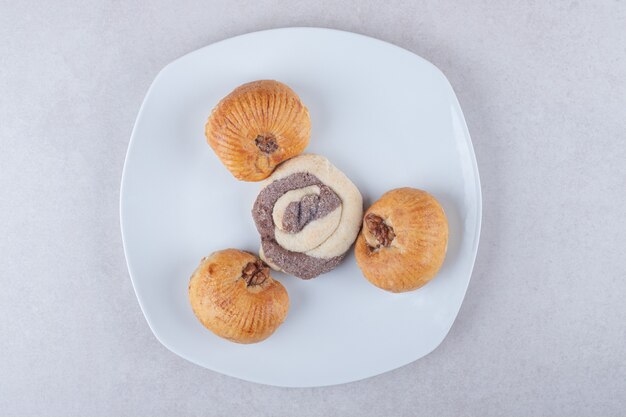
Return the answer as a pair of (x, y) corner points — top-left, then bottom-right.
(252, 154), (363, 279)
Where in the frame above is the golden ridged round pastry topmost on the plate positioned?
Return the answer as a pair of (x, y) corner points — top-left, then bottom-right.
(205, 80), (311, 181)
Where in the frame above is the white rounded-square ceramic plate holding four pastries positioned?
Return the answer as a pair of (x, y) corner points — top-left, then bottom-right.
(121, 28), (481, 387)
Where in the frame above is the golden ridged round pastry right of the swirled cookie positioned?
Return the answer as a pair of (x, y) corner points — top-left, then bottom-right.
(355, 188), (448, 292)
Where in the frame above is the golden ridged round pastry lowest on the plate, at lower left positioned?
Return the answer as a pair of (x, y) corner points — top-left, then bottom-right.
(189, 249), (289, 343)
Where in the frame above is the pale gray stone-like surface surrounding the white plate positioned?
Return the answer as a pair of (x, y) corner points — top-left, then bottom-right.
(0, 0), (626, 417)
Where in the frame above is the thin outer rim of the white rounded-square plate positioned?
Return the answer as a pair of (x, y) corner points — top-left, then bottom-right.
(119, 26), (483, 388)
